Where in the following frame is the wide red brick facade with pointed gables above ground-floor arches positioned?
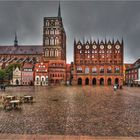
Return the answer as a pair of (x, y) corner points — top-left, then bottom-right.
(72, 40), (123, 85)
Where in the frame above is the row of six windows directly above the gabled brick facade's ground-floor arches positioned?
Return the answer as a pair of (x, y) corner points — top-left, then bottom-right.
(77, 67), (120, 73)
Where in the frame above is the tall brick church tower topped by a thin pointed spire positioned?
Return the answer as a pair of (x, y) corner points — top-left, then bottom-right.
(43, 2), (66, 62)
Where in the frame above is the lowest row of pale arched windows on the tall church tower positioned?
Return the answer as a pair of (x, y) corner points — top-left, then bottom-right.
(45, 49), (59, 57)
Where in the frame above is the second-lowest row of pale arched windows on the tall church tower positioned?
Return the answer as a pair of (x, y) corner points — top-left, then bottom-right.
(45, 37), (59, 45)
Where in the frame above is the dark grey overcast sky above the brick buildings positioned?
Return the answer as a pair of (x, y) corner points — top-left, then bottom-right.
(0, 1), (140, 62)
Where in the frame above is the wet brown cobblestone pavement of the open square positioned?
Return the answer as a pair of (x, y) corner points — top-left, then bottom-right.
(0, 86), (140, 136)
